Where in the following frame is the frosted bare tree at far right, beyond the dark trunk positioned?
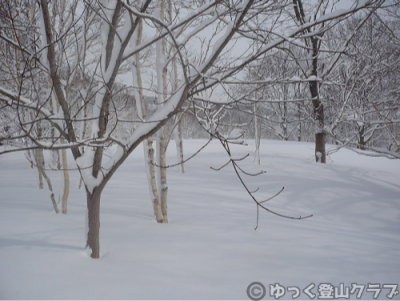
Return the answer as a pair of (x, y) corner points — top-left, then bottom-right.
(328, 10), (400, 157)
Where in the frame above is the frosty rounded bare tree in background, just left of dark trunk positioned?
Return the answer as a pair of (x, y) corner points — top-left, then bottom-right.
(245, 51), (311, 140)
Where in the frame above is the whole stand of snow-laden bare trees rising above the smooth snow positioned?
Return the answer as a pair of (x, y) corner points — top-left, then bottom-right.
(0, 0), (400, 258)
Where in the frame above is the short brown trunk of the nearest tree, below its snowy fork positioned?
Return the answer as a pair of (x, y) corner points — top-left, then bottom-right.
(86, 187), (101, 258)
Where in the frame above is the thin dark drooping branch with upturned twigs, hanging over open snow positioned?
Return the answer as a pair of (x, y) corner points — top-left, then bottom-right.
(210, 132), (313, 230)
